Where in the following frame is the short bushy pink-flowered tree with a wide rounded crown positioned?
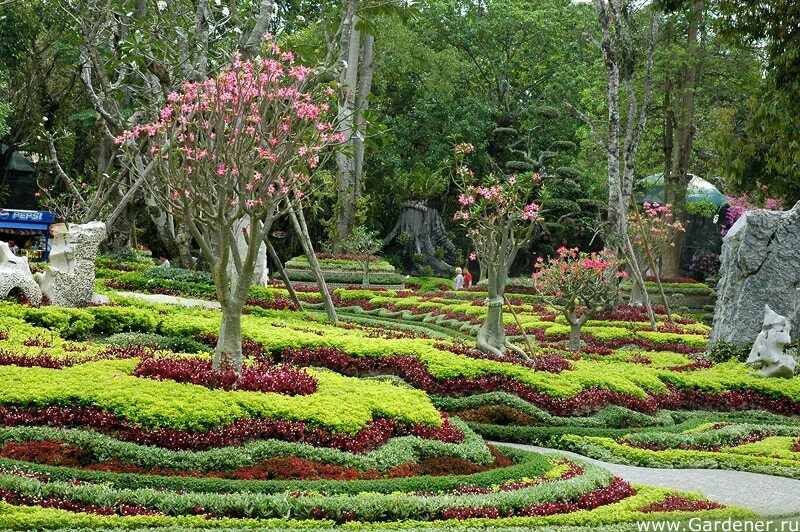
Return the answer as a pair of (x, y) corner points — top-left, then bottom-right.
(532, 247), (627, 351)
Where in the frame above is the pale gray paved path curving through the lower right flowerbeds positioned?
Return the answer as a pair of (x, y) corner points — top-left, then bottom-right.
(490, 442), (800, 516)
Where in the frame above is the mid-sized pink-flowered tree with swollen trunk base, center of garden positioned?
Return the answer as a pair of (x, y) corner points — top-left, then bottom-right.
(453, 144), (541, 356)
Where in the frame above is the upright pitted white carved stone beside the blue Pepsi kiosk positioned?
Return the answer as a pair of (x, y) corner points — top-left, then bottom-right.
(37, 222), (106, 307)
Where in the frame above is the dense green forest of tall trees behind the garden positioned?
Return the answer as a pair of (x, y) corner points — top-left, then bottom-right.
(0, 0), (800, 273)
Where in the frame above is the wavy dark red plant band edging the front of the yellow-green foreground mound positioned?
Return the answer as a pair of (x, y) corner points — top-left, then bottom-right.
(0, 406), (464, 453)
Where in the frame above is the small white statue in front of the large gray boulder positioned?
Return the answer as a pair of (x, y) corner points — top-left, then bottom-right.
(745, 305), (797, 379)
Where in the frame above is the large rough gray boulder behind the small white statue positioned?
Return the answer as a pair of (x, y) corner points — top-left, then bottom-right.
(711, 202), (800, 346)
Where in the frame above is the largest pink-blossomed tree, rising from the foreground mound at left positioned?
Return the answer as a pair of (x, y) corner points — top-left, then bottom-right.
(116, 39), (342, 371)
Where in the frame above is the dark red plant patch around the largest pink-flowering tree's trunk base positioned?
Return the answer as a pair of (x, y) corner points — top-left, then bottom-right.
(131, 357), (317, 395)
